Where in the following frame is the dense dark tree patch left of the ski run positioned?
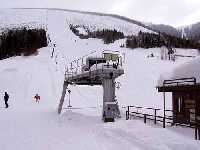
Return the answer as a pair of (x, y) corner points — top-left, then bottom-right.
(0, 28), (47, 59)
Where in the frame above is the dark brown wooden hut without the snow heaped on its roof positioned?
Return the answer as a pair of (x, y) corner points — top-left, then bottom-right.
(158, 77), (200, 126)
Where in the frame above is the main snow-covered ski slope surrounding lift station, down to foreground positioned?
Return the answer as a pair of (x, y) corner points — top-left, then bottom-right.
(0, 10), (200, 150)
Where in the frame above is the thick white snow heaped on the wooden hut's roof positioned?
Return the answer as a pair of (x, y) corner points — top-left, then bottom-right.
(158, 56), (200, 86)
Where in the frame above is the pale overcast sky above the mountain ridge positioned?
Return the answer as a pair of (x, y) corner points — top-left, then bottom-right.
(0, 0), (200, 27)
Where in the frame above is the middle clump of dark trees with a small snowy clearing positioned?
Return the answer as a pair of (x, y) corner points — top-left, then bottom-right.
(70, 24), (125, 44)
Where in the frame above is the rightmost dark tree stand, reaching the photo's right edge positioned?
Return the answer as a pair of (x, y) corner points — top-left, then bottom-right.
(126, 31), (200, 49)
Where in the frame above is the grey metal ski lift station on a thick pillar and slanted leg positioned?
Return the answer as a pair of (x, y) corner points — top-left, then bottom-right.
(58, 51), (124, 122)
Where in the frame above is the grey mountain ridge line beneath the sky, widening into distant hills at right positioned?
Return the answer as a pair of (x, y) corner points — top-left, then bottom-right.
(11, 7), (200, 41)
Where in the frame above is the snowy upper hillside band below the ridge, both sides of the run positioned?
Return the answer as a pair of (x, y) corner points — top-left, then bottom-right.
(0, 9), (153, 35)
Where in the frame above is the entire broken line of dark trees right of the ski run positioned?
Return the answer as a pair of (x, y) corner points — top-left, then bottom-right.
(70, 24), (200, 49)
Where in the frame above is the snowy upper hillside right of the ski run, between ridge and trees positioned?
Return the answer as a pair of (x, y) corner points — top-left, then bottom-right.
(57, 11), (153, 35)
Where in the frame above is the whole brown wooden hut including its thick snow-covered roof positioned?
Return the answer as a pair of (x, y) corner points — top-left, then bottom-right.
(157, 57), (200, 138)
